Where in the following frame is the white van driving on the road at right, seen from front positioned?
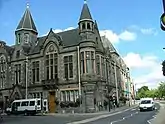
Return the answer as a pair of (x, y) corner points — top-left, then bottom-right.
(139, 98), (155, 111)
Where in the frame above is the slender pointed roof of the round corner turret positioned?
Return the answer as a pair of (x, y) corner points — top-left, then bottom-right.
(79, 0), (92, 21)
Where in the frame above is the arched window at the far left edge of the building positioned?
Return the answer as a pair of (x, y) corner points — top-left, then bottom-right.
(0, 56), (6, 88)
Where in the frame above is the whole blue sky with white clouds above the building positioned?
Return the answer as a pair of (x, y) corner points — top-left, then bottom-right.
(0, 0), (165, 88)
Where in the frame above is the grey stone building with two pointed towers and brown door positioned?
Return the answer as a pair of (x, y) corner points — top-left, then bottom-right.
(0, 3), (129, 112)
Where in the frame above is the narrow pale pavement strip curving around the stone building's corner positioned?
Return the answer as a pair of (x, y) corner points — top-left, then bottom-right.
(44, 104), (137, 116)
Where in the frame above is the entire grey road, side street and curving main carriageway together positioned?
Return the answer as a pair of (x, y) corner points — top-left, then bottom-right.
(0, 104), (159, 124)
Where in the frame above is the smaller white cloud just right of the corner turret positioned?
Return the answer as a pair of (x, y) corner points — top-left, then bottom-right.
(100, 30), (137, 43)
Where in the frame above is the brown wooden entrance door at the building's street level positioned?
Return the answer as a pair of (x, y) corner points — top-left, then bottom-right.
(49, 91), (56, 113)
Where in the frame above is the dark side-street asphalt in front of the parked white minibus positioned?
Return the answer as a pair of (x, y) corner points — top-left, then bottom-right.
(0, 115), (94, 124)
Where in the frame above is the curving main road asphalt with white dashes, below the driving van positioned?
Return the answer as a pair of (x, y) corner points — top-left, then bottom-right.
(86, 104), (160, 124)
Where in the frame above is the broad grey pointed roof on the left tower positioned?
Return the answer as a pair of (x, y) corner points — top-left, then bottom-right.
(16, 2), (37, 33)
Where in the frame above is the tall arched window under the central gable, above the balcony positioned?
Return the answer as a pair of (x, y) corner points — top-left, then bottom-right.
(45, 45), (58, 80)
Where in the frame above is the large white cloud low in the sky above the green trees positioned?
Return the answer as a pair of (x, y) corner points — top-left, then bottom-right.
(123, 53), (164, 89)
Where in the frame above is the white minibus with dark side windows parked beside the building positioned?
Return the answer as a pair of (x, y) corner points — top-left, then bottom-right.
(6, 98), (47, 115)
